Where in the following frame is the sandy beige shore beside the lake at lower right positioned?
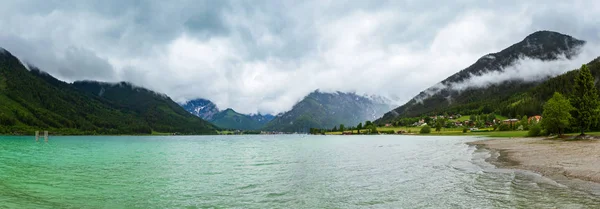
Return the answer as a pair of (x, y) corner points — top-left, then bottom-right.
(469, 138), (600, 183)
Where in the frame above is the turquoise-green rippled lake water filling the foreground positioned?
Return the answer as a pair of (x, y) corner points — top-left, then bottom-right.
(0, 135), (600, 208)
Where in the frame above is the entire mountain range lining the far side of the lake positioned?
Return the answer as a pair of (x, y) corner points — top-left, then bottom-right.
(0, 31), (600, 134)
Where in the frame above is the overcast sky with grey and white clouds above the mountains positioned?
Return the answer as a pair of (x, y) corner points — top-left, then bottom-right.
(0, 0), (600, 113)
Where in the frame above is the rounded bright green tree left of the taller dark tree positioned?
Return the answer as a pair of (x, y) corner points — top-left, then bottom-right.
(542, 92), (573, 135)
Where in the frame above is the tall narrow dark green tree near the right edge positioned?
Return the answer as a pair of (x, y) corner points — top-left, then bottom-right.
(571, 65), (599, 134)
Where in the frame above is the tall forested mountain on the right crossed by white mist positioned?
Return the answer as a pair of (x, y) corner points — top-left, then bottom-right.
(376, 31), (585, 124)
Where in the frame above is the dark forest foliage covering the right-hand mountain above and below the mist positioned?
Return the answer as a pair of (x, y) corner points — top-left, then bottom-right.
(376, 31), (584, 123)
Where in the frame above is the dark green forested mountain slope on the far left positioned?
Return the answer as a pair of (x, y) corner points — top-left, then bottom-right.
(0, 49), (215, 134)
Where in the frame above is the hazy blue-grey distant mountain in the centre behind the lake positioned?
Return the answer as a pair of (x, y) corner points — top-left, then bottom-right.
(263, 91), (391, 132)
